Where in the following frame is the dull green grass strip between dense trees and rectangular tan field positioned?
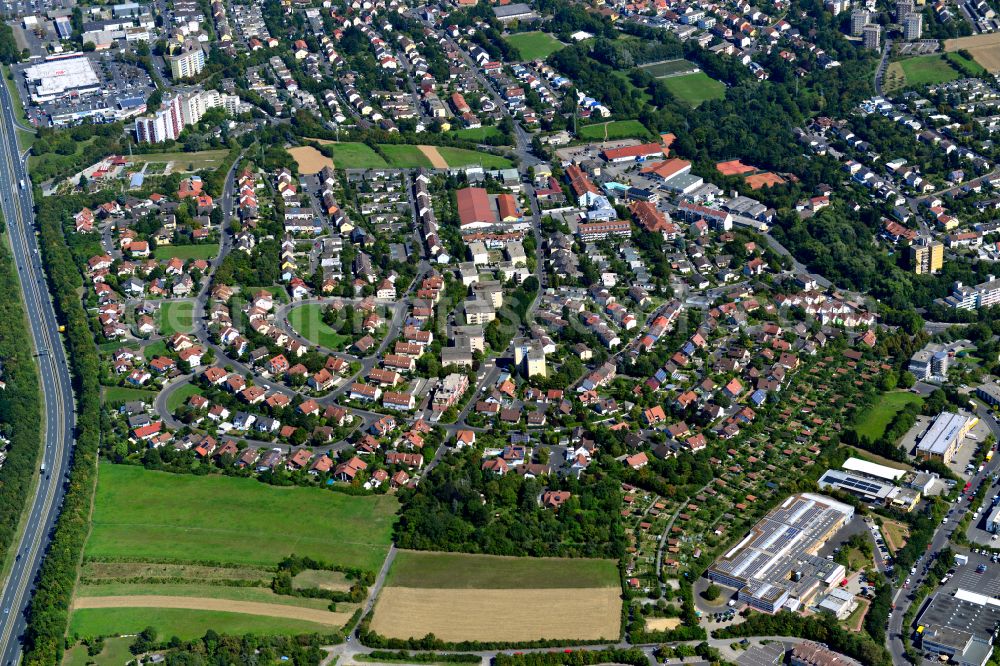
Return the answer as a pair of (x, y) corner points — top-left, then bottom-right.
(386, 550), (620, 589)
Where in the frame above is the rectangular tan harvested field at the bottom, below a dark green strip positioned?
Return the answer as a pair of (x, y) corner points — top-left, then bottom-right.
(371, 587), (621, 643)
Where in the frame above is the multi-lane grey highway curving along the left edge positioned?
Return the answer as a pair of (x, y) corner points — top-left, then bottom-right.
(0, 66), (75, 666)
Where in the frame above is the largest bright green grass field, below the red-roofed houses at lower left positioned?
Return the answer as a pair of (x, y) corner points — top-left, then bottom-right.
(86, 464), (398, 568)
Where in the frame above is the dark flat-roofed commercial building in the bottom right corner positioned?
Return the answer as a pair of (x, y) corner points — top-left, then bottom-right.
(918, 589), (1000, 666)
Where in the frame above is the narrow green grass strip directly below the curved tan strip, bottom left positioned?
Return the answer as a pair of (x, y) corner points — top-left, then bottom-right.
(69, 608), (338, 640)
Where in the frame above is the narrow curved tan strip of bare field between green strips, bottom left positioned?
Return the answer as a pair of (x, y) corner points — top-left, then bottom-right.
(73, 594), (351, 627)
